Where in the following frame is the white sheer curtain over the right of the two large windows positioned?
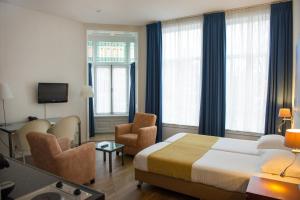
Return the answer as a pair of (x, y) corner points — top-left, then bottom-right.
(226, 6), (270, 133)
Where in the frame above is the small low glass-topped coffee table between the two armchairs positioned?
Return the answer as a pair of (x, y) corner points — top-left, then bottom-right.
(96, 141), (124, 173)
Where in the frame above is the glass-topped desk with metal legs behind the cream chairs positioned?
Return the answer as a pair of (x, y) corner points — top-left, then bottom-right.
(0, 118), (81, 158)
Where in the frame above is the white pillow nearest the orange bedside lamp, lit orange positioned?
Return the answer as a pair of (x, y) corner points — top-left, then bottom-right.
(260, 149), (295, 175)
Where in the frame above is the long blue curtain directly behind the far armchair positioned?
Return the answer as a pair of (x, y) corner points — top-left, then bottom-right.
(145, 22), (162, 142)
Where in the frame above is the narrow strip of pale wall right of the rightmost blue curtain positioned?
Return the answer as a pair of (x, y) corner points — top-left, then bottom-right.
(293, 0), (300, 128)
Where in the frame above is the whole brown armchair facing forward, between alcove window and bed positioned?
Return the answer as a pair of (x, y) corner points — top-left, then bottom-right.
(115, 113), (157, 155)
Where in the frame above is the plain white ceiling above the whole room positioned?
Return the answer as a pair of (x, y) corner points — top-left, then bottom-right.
(0, 0), (274, 25)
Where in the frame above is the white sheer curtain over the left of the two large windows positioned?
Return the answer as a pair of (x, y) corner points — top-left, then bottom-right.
(162, 17), (203, 126)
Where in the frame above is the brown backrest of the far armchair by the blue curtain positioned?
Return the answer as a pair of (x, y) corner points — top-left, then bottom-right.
(132, 113), (156, 133)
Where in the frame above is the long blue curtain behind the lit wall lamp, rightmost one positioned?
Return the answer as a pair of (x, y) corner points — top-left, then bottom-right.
(265, 1), (293, 134)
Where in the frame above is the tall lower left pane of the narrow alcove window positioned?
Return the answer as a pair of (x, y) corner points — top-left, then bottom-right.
(95, 67), (111, 114)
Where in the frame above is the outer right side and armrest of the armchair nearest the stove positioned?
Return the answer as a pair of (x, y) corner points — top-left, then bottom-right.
(55, 142), (96, 184)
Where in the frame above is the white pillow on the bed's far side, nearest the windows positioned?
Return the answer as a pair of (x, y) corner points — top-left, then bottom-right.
(257, 135), (288, 150)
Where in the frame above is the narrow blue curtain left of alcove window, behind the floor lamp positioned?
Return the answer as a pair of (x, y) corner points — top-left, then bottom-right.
(88, 63), (95, 137)
